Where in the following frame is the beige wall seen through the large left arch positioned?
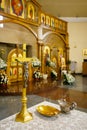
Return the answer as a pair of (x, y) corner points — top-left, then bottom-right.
(0, 23), (37, 60)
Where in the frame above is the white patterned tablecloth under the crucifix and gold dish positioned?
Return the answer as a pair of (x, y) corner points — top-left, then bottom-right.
(0, 101), (87, 130)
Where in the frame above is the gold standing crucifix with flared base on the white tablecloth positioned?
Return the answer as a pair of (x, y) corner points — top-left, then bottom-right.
(15, 44), (33, 123)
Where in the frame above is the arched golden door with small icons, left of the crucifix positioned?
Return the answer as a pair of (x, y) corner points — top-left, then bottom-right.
(7, 48), (23, 82)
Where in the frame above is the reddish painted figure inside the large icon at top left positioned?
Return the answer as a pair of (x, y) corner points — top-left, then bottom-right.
(11, 0), (23, 16)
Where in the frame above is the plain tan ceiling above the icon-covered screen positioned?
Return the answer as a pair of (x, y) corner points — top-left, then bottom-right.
(37, 0), (87, 21)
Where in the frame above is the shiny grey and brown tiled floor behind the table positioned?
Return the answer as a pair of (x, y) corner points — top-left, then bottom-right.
(0, 75), (87, 120)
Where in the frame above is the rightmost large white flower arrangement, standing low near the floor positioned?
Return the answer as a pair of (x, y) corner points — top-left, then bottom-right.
(62, 71), (75, 85)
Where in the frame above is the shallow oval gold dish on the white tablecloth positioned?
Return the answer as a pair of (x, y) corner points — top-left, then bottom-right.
(36, 105), (60, 116)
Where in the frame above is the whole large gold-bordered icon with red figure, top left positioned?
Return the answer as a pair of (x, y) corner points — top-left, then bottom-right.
(10, 0), (24, 18)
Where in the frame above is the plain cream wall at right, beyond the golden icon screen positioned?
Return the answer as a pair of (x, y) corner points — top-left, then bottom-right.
(68, 22), (87, 73)
